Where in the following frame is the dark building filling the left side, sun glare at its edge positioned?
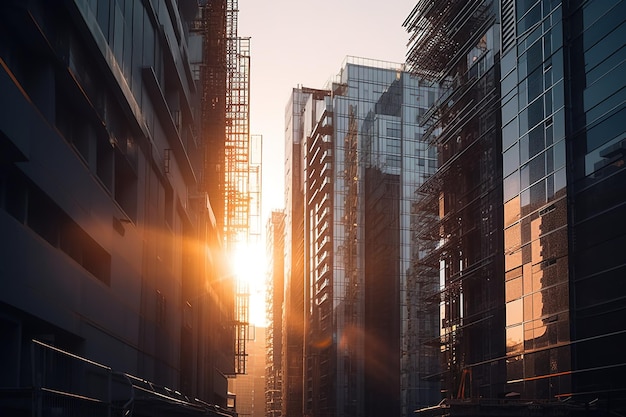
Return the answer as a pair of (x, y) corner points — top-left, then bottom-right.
(0, 0), (241, 416)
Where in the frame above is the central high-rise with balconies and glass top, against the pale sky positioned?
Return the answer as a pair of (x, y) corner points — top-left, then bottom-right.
(285, 57), (436, 416)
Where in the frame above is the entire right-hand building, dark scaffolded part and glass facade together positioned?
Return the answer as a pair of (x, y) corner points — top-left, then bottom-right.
(405, 1), (626, 415)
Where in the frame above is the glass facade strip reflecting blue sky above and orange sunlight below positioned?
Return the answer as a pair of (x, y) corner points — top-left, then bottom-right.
(501, 1), (571, 398)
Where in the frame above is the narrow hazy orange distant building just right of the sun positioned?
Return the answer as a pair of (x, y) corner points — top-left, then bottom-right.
(265, 211), (286, 417)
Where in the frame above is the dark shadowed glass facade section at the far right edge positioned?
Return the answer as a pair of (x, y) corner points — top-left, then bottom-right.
(564, 0), (626, 408)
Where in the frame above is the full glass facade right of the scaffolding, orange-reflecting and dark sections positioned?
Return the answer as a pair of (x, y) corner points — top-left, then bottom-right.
(501, 1), (626, 413)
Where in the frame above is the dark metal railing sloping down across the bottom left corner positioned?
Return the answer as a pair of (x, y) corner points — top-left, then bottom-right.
(0, 340), (235, 417)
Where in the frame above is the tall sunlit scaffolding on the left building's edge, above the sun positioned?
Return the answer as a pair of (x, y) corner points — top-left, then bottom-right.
(193, 0), (254, 374)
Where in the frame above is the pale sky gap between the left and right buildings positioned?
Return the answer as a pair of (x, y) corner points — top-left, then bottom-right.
(237, 0), (417, 326)
